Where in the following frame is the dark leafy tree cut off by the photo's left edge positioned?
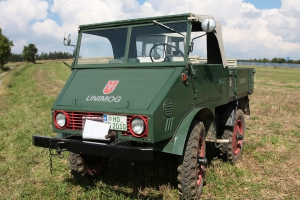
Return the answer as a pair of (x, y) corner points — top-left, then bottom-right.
(0, 28), (14, 68)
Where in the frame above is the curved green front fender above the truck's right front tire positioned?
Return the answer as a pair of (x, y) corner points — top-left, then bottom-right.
(162, 107), (204, 155)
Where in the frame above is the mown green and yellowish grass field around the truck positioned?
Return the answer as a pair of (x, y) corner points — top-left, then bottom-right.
(0, 62), (300, 199)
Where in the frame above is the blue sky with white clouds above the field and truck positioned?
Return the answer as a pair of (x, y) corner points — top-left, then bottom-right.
(0, 0), (300, 60)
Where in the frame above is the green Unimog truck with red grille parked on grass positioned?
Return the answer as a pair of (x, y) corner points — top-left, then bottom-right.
(32, 13), (255, 199)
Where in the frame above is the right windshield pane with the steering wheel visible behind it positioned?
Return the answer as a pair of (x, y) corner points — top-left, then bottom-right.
(129, 22), (187, 63)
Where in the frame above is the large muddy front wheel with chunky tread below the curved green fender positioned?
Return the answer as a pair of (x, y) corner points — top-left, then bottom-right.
(177, 122), (206, 199)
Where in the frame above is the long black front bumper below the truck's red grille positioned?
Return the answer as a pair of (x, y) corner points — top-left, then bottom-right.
(32, 135), (153, 161)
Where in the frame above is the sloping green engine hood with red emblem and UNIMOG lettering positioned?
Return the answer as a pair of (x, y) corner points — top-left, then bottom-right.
(57, 68), (175, 110)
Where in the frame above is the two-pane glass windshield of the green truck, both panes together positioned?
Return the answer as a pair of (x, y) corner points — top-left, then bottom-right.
(78, 22), (187, 64)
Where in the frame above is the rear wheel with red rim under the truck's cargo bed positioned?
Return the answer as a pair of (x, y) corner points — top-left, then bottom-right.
(221, 110), (245, 164)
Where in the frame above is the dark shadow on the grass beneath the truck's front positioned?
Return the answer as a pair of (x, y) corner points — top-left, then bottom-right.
(66, 153), (178, 199)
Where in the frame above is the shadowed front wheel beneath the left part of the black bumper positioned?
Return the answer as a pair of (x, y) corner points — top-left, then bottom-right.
(68, 152), (108, 178)
